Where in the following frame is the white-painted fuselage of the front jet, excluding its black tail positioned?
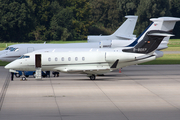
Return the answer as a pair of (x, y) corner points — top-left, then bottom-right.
(5, 49), (148, 74)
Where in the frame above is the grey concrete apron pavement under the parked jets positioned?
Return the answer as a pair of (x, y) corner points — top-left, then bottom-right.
(0, 65), (180, 120)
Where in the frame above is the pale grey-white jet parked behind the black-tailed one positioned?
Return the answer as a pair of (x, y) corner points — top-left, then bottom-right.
(0, 16), (138, 62)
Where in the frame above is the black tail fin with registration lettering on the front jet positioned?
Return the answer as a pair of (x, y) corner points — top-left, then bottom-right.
(122, 30), (173, 54)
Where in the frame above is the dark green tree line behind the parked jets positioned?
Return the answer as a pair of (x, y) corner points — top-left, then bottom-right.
(0, 0), (180, 42)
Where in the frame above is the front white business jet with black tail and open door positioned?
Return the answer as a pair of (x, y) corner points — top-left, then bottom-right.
(5, 30), (172, 80)
